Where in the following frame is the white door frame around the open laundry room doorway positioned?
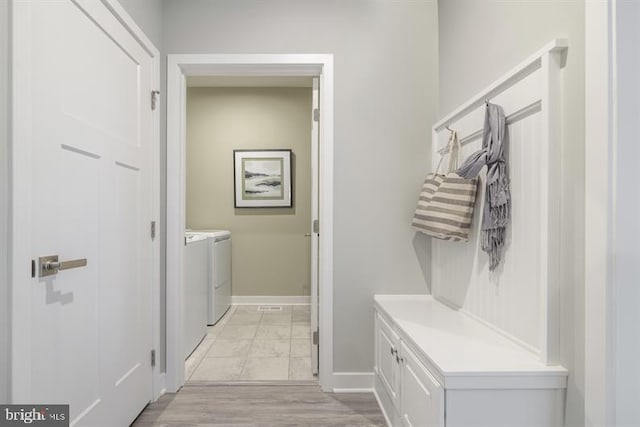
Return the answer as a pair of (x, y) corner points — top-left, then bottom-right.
(165, 54), (334, 392)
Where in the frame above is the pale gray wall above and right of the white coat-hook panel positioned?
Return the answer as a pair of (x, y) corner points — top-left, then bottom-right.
(438, 0), (585, 426)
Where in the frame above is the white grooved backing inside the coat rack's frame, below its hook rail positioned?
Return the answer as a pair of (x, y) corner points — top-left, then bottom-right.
(433, 113), (541, 348)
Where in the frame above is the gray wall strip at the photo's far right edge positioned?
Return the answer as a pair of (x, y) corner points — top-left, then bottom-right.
(613, 1), (640, 426)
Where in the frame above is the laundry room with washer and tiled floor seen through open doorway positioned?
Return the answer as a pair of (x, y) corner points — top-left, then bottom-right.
(184, 76), (314, 380)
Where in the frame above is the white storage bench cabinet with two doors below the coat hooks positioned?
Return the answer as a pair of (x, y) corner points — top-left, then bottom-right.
(374, 295), (567, 427)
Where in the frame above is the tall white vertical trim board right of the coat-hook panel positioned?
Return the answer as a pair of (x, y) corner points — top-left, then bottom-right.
(584, 0), (618, 427)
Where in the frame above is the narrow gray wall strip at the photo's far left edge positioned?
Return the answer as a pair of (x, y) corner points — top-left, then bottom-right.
(0, 1), (11, 403)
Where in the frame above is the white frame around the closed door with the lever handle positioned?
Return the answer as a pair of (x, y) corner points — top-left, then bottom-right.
(7, 0), (164, 402)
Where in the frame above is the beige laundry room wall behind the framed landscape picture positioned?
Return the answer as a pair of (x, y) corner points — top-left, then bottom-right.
(187, 88), (311, 295)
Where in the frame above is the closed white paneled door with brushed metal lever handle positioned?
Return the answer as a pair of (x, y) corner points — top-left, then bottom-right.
(12, 0), (154, 426)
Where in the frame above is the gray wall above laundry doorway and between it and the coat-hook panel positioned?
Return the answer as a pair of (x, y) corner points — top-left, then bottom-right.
(163, 0), (437, 372)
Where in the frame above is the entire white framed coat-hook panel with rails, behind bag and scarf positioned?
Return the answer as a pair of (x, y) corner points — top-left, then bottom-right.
(432, 41), (562, 363)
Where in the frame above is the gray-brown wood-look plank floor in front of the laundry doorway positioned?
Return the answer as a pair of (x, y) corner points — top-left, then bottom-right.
(132, 382), (386, 427)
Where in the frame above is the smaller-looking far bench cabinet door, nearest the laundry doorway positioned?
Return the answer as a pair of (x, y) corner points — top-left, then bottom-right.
(376, 313), (400, 408)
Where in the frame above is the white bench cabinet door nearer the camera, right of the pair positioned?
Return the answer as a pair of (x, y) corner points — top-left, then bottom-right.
(400, 343), (444, 427)
